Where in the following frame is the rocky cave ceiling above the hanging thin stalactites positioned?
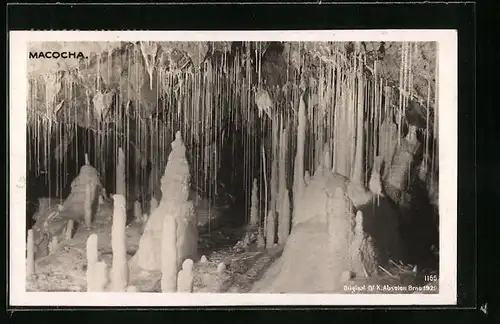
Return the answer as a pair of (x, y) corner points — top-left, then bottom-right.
(28, 42), (436, 130)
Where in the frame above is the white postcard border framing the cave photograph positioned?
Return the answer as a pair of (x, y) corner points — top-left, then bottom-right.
(6, 30), (458, 307)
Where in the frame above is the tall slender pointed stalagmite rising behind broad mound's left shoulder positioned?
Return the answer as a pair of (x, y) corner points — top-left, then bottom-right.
(293, 97), (306, 228)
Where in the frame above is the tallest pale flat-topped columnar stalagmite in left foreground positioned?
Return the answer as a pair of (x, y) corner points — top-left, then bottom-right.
(111, 194), (129, 292)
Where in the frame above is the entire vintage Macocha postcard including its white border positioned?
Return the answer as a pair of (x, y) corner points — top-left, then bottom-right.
(9, 30), (458, 307)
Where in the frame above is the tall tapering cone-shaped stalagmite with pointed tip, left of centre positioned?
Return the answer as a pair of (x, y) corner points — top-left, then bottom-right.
(132, 132), (198, 274)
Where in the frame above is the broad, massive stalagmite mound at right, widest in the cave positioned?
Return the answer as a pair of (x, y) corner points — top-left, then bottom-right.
(253, 158), (398, 293)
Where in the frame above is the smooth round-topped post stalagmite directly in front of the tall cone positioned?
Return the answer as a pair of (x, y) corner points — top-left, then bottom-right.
(161, 211), (177, 292)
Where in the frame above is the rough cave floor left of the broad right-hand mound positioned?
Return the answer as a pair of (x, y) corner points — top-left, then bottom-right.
(26, 213), (282, 293)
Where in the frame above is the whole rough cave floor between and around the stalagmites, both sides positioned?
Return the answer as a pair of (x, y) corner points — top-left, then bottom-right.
(26, 205), (439, 294)
